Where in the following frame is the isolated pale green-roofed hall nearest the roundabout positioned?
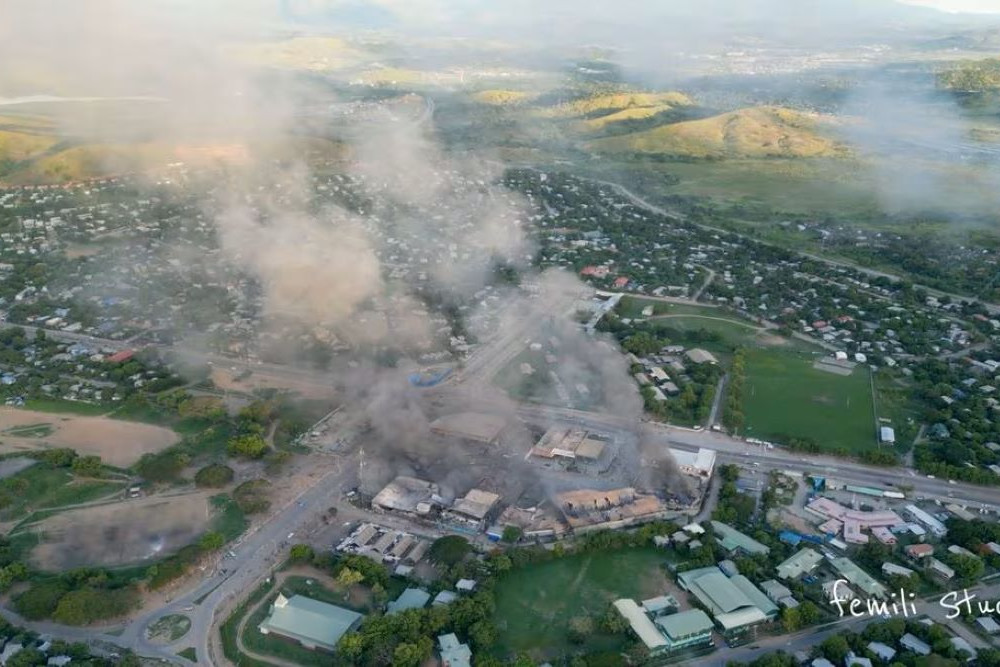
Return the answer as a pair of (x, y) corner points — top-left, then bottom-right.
(260, 593), (361, 651)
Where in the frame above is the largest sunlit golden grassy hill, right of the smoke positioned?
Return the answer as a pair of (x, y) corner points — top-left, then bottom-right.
(586, 107), (845, 158)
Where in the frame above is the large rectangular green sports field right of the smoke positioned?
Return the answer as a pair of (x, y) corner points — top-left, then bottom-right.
(744, 349), (876, 453)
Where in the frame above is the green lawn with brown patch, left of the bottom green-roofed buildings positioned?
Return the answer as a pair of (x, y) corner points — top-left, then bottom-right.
(494, 549), (666, 659)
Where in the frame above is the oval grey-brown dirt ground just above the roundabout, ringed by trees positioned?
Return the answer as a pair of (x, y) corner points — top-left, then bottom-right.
(31, 493), (211, 571)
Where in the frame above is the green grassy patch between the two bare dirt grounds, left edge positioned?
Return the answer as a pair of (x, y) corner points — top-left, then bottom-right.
(0, 463), (124, 521)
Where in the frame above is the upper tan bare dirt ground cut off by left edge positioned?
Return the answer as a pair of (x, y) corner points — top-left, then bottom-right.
(0, 407), (179, 468)
